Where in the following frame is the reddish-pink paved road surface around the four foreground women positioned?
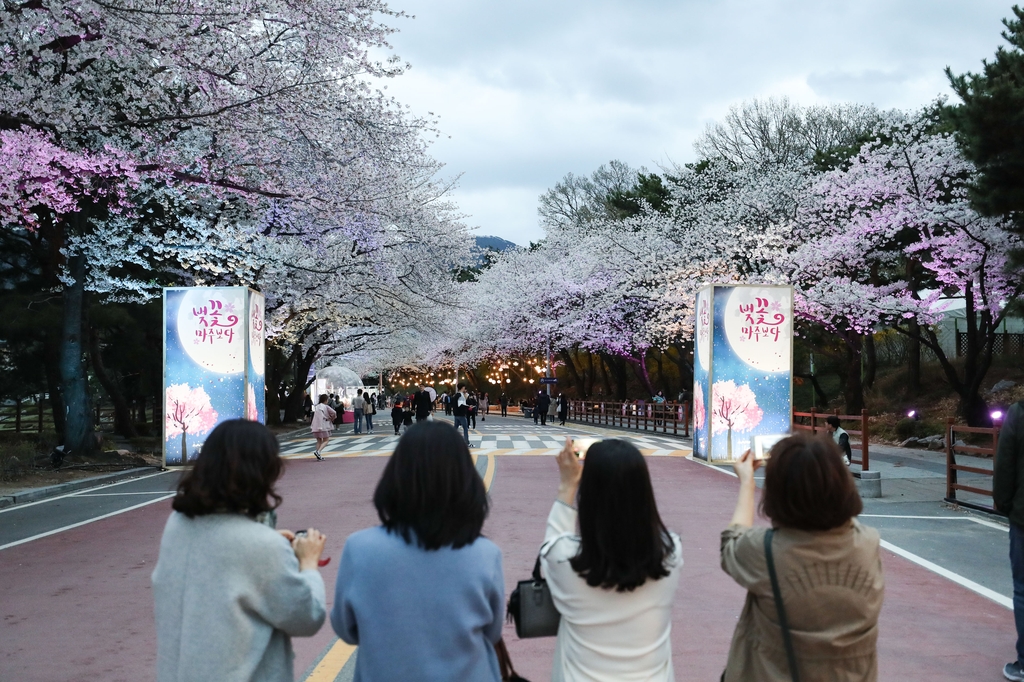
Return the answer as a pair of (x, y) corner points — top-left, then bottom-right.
(0, 450), (1015, 682)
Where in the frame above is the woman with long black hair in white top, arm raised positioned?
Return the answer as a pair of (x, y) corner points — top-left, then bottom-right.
(541, 439), (683, 682)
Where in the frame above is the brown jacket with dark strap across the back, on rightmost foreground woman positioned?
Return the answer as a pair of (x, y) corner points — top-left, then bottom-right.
(721, 520), (885, 682)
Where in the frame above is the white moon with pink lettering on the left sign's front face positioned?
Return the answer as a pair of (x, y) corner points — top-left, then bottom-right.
(177, 288), (246, 374)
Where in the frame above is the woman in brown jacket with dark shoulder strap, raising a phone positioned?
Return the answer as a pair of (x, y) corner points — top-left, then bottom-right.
(721, 434), (885, 682)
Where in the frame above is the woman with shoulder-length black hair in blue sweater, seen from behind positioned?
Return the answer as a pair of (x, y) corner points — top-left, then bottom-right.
(331, 421), (505, 682)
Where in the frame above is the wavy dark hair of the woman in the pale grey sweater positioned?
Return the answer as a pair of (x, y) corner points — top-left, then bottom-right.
(171, 419), (284, 518)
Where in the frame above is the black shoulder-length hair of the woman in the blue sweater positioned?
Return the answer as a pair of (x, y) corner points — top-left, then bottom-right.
(374, 421), (489, 550)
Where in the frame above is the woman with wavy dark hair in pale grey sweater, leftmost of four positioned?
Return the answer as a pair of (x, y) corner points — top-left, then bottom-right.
(153, 419), (327, 682)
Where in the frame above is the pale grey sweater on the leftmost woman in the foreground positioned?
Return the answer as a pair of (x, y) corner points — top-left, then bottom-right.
(153, 512), (327, 682)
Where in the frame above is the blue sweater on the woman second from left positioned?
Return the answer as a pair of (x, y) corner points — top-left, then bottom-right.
(331, 526), (505, 682)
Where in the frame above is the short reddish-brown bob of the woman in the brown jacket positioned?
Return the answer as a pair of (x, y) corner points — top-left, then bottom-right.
(761, 433), (864, 530)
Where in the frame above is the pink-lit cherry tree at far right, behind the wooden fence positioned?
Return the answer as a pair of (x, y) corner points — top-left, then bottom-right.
(788, 114), (1024, 424)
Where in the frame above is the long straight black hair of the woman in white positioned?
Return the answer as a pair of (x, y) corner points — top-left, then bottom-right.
(569, 439), (674, 592)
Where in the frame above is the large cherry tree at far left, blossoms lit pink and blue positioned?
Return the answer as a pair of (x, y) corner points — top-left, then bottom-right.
(0, 0), (464, 446)
